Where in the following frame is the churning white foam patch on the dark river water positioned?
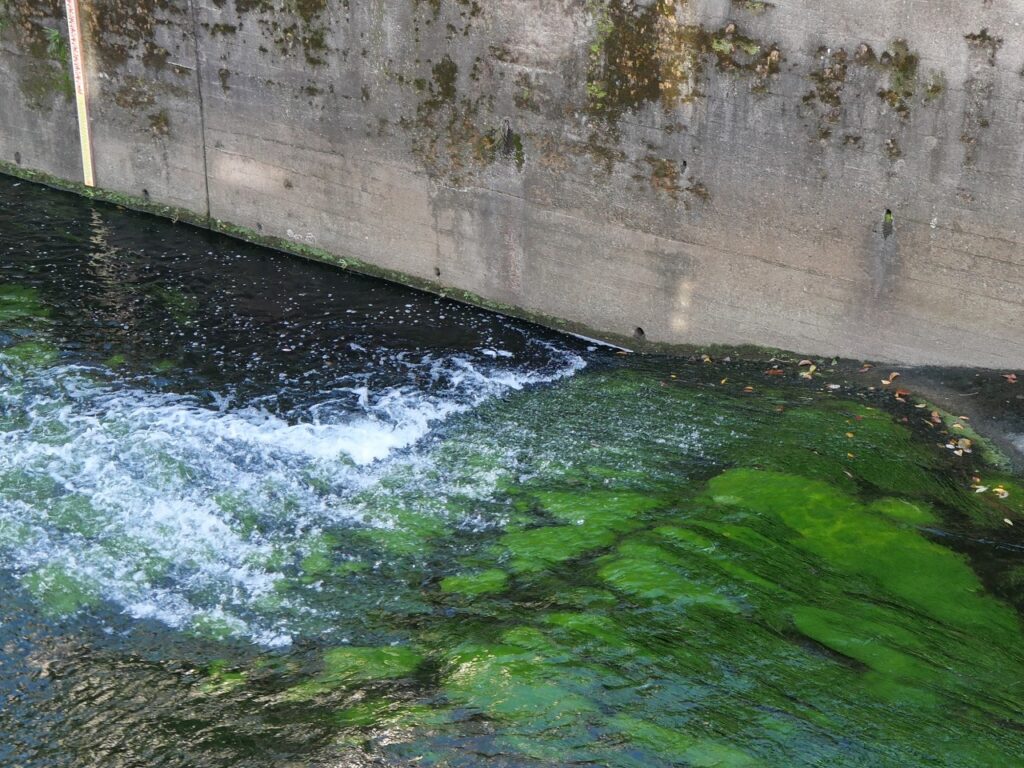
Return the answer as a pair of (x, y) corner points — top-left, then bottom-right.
(0, 350), (586, 646)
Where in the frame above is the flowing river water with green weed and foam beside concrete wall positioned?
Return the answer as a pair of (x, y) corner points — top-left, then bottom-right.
(0, 178), (1024, 768)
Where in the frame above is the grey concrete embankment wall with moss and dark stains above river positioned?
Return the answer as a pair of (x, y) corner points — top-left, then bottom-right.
(0, 0), (1024, 368)
